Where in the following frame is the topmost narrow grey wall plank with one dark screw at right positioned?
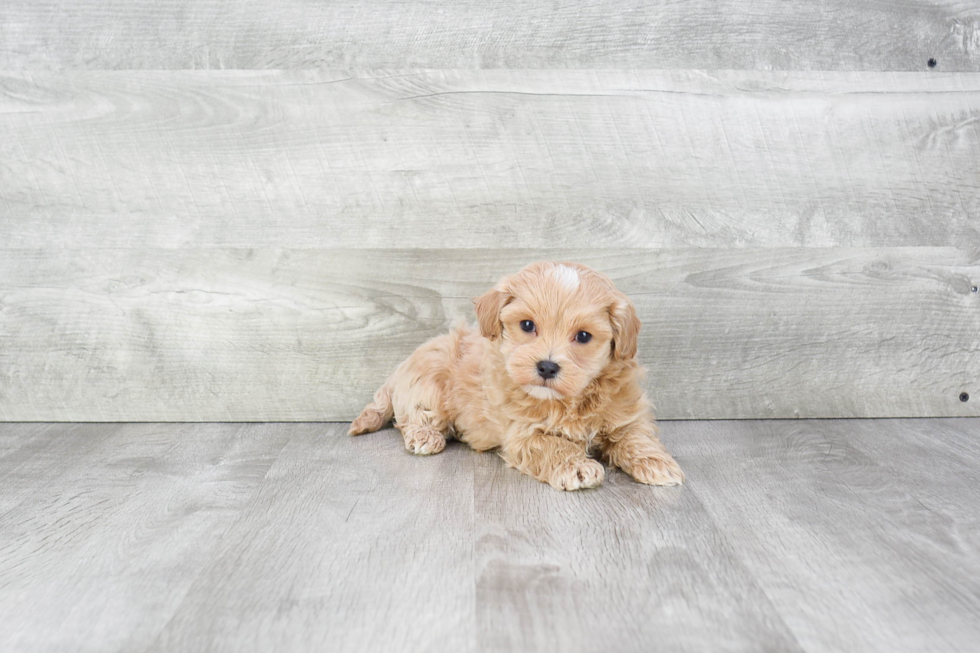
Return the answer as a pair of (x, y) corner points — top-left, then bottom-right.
(0, 0), (980, 71)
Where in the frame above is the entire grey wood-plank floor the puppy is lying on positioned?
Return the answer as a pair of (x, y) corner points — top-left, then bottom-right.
(0, 419), (980, 652)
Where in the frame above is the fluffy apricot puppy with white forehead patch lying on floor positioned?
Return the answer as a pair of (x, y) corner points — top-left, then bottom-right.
(350, 262), (684, 490)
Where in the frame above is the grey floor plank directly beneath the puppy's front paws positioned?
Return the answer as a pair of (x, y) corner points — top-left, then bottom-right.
(475, 456), (803, 653)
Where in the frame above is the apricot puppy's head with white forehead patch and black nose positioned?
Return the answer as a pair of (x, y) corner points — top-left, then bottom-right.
(473, 262), (640, 399)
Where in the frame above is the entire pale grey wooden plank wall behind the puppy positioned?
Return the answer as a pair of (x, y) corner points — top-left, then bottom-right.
(0, 0), (980, 421)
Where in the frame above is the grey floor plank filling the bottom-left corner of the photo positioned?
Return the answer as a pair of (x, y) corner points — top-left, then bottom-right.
(0, 424), (292, 651)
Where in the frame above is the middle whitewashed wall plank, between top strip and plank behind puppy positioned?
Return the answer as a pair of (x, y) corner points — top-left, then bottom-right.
(0, 70), (980, 249)
